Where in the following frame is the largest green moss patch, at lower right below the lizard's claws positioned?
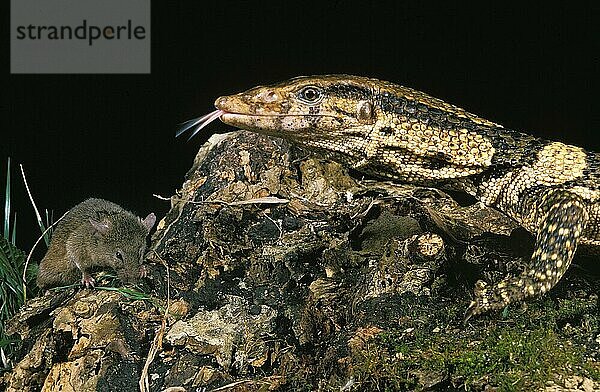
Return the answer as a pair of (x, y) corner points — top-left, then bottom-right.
(344, 324), (600, 391)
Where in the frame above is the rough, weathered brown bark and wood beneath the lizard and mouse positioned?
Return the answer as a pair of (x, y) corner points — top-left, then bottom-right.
(0, 132), (600, 391)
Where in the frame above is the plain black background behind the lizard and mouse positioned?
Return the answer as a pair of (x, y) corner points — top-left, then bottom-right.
(0, 0), (600, 250)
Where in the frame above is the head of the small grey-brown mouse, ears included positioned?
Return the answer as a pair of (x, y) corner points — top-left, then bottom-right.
(90, 213), (156, 282)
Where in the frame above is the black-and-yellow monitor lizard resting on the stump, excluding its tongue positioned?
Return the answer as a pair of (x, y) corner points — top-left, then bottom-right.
(204, 75), (600, 319)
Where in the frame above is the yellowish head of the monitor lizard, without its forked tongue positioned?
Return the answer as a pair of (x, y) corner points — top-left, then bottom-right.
(215, 75), (377, 148)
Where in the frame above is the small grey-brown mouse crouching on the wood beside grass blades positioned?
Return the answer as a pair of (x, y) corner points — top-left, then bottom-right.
(36, 198), (156, 289)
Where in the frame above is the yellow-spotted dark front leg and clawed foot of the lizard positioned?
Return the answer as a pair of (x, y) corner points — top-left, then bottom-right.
(465, 189), (588, 322)
